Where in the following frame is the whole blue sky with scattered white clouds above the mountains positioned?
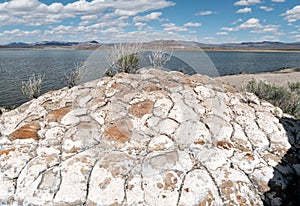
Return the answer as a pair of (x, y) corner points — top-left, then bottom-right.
(0, 0), (300, 44)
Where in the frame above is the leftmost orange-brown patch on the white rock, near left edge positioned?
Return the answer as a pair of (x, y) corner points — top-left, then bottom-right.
(8, 122), (41, 141)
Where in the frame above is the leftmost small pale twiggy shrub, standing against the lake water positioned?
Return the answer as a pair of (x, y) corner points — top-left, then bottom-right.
(21, 74), (44, 99)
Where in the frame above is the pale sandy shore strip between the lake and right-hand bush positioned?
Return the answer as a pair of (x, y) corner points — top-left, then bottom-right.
(217, 68), (300, 89)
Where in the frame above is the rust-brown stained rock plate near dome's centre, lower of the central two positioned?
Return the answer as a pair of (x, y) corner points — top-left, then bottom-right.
(104, 119), (132, 143)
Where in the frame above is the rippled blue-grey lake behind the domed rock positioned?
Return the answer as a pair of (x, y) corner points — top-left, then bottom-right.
(0, 49), (300, 107)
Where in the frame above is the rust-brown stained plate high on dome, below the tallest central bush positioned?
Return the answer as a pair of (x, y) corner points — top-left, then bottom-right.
(128, 100), (154, 118)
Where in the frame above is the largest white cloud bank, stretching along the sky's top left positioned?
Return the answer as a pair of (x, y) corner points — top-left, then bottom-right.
(0, 0), (175, 26)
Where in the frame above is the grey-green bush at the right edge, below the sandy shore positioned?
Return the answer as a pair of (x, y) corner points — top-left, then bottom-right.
(245, 79), (300, 118)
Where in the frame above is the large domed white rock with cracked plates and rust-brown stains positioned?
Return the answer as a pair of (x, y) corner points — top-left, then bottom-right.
(0, 69), (300, 205)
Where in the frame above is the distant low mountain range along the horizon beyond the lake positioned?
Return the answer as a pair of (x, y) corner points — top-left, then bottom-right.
(0, 40), (300, 50)
